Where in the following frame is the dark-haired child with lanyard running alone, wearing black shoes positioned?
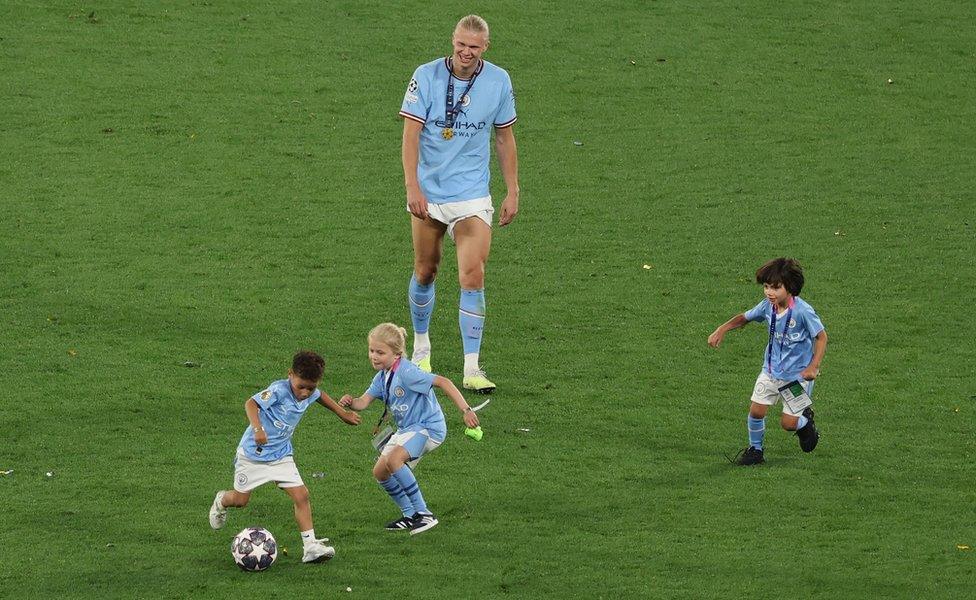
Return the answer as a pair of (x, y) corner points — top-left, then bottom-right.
(708, 258), (827, 465)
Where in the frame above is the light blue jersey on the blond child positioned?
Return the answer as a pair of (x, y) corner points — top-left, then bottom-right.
(366, 358), (447, 442)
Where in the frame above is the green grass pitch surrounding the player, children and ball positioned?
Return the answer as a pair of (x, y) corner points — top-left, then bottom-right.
(0, 1), (976, 598)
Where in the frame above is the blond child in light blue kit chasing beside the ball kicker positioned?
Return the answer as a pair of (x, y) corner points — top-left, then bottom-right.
(339, 323), (478, 535)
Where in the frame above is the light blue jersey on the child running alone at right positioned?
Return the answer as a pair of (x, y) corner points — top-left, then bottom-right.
(745, 297), (824, 380)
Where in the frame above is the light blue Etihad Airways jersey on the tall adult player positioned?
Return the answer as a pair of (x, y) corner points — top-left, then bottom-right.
(400, 58), (517, 204)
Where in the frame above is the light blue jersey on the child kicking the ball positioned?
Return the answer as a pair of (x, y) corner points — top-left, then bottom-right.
(237, 379), (322, 462)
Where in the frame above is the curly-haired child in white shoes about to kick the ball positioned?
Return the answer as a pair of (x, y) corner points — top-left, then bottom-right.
(210, 351), (360, 563)
